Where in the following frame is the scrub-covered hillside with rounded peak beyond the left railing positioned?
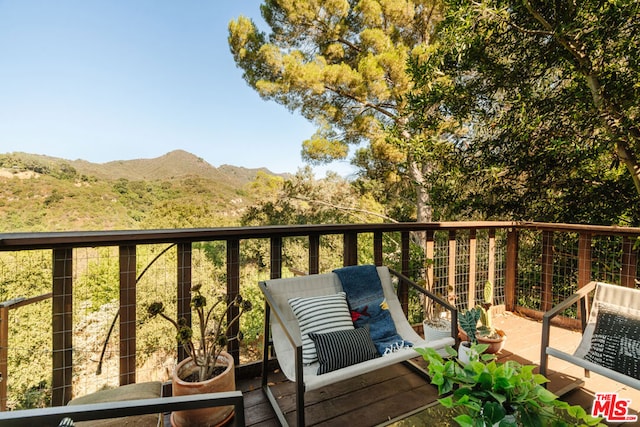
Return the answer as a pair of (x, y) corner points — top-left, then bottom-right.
(0, 150), (280, 232)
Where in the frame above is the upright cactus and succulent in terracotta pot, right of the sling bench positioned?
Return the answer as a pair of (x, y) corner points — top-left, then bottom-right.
(458, 280), (507, 354)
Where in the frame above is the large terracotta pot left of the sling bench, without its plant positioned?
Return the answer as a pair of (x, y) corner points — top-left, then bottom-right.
(171, 351), (236, 427)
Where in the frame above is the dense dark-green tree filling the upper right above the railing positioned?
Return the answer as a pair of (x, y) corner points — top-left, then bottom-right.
(409, 0), (640, 225)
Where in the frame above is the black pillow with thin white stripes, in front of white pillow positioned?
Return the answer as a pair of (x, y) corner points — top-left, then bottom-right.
(309, 328), (380, 375)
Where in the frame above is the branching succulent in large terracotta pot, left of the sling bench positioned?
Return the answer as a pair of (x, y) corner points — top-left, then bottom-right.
(147, 285), (252, 426)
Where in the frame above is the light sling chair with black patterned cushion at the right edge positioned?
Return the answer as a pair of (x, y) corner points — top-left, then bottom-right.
(540, 282), (640, 390)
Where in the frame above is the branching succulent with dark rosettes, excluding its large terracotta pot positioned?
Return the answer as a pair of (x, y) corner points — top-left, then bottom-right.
(147, 285), (253, 381)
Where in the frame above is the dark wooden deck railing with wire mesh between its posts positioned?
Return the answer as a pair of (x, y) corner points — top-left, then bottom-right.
(0, 223), (640, 409)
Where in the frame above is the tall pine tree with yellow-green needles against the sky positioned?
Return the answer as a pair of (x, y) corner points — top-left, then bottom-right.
(228, 0), (442, 221)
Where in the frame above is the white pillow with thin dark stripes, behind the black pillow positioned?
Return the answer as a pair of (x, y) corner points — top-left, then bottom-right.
(289, 292), (353, 364)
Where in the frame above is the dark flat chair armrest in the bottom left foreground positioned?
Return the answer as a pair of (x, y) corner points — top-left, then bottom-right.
(0, 391), (245, 427)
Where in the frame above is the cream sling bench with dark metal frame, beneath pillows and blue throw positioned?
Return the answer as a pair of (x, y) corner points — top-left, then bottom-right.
(259, 267), (457, 426)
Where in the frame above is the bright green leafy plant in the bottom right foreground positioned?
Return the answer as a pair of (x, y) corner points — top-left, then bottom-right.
(416, 344), (604, 427)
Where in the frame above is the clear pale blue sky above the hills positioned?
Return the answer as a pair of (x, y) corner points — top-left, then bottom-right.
(0, 0), (351, 175)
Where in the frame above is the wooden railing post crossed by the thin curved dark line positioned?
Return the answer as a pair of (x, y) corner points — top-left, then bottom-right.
(120, 246), (137, 386)
